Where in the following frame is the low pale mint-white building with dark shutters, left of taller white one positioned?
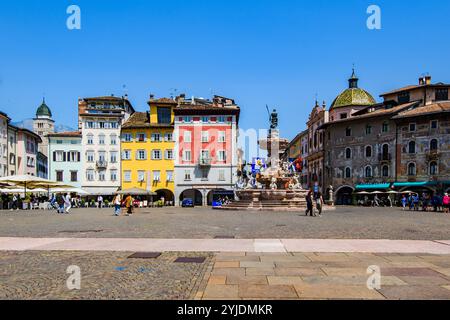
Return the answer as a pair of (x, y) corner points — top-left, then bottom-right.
(48, 131), (84, 188)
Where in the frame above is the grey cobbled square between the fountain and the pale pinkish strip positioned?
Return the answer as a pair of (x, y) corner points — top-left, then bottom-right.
(0, 207), (450, 240)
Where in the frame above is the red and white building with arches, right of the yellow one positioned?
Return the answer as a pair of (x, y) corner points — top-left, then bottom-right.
(175, 96), (240, 205)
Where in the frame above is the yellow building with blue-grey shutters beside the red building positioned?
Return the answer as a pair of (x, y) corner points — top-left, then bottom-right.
(121, 97), (177, 204)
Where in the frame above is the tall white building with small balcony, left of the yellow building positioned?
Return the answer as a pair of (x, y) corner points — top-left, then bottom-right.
(78, 96), (134, 195)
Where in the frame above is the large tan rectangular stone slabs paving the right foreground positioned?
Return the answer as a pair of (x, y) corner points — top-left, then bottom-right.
(195, 252), (450, 300)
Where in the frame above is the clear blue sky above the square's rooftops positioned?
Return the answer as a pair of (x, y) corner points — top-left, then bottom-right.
(0, 0), (450, 138)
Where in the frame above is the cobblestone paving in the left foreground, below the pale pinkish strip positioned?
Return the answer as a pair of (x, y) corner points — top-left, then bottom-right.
(0, 251), (212, 300)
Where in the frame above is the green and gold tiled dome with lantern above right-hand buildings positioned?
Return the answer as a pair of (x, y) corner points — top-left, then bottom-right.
(330, 70), (376, 109)
